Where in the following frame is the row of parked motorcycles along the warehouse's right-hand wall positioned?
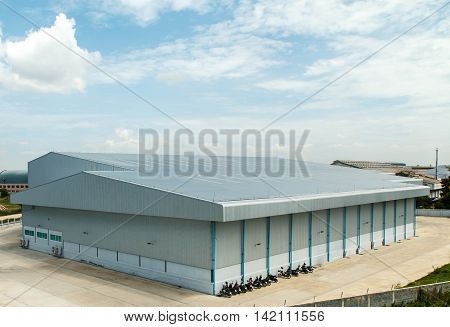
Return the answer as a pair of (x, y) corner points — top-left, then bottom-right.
(219, 263), (314, 298)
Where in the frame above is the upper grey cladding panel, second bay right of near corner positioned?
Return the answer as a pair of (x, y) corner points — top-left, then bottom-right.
(245, 218), (267, 262)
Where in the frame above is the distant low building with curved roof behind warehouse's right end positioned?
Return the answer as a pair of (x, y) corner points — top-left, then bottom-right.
(331, 160), (442, 199)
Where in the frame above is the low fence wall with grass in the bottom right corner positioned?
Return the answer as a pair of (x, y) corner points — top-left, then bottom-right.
(296, 282), (450, 307)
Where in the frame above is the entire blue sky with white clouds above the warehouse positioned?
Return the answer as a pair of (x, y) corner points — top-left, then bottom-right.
(0, 0), (450, 169)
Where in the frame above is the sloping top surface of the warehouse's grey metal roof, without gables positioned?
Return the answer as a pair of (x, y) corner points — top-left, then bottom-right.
(51, 153), (424, 202)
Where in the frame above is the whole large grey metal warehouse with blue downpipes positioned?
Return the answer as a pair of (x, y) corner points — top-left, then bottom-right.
(13, 152), (428, 294)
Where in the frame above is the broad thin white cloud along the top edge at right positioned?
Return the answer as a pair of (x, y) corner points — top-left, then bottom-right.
(227, 0), (436, 37)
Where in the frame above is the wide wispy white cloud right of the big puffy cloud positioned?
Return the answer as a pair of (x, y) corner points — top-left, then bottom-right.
(100, 31), (289, 83)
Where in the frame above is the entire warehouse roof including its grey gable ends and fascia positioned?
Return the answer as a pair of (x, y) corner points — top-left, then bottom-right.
(13, 153), (429, 221)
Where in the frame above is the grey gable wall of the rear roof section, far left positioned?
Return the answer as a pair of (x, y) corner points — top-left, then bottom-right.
(28, 152), (126, 188)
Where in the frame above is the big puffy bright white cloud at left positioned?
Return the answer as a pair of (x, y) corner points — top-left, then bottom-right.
(0, 14), (101, 92)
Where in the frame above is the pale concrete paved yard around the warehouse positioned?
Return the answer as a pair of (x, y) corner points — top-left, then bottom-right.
(0, 217), (450, 306)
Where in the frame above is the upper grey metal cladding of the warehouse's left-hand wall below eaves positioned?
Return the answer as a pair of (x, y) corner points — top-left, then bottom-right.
(23, 206), (212, 269)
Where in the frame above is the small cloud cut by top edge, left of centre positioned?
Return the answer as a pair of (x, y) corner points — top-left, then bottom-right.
(100, 0), (218, 25)
